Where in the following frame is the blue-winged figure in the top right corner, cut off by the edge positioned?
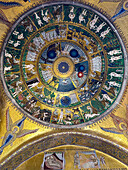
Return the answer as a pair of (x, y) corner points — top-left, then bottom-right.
(99, 0), (128, 21)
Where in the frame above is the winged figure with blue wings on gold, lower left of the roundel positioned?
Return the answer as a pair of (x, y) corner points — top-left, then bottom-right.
(0, 108), (38, 155)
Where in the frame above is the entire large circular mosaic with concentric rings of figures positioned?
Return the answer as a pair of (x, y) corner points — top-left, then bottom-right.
(1, 2), (126, 128)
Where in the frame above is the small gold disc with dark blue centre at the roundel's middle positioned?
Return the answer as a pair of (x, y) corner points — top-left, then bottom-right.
(53, 56), (75, 78)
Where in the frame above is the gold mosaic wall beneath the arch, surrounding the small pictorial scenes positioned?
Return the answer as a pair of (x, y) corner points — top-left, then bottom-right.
(17, 146), (127, 170)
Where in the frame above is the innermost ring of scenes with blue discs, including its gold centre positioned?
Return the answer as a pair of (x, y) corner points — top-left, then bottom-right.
(37, 40), (90, 93)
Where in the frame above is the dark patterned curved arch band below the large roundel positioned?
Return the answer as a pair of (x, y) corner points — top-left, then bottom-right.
(0, 132), (128, 170)
